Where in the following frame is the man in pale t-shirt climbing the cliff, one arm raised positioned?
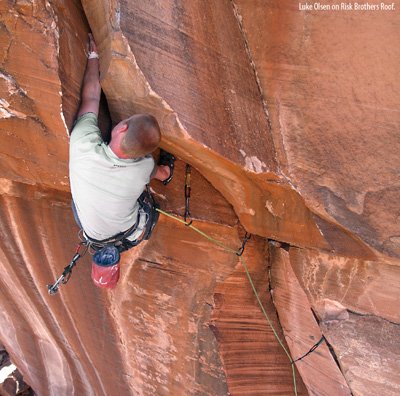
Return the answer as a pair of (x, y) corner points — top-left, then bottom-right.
(69, 34), (175, 288)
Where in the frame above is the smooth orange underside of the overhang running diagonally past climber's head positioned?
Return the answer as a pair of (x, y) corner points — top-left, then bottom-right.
(83, 1), (374, 258)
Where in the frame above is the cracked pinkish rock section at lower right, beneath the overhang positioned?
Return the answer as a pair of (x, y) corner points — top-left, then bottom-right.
(271, 247), (400, 395)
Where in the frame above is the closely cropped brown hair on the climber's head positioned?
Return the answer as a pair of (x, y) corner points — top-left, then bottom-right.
(121, 114), (161, 158)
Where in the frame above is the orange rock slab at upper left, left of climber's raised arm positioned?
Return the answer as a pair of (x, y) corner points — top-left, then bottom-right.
(0, 0), (85, 191)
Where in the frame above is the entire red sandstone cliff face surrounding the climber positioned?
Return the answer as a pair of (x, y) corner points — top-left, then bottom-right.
(0, 0), (400, 395)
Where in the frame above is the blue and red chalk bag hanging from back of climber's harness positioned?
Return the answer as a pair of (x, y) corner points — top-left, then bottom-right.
(92, 246), (120, 289)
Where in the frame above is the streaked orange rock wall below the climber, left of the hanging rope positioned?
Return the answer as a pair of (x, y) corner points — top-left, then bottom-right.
(0, 176), (303, 395)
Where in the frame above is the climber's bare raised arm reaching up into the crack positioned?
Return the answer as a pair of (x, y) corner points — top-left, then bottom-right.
(77, 33), (101, 118)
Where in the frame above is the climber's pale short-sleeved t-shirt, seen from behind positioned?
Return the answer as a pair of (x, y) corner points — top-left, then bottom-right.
(69, 113), (154, 240)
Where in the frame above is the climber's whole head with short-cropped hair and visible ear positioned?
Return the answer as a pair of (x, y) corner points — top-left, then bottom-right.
(110, 114), (161, 158)
